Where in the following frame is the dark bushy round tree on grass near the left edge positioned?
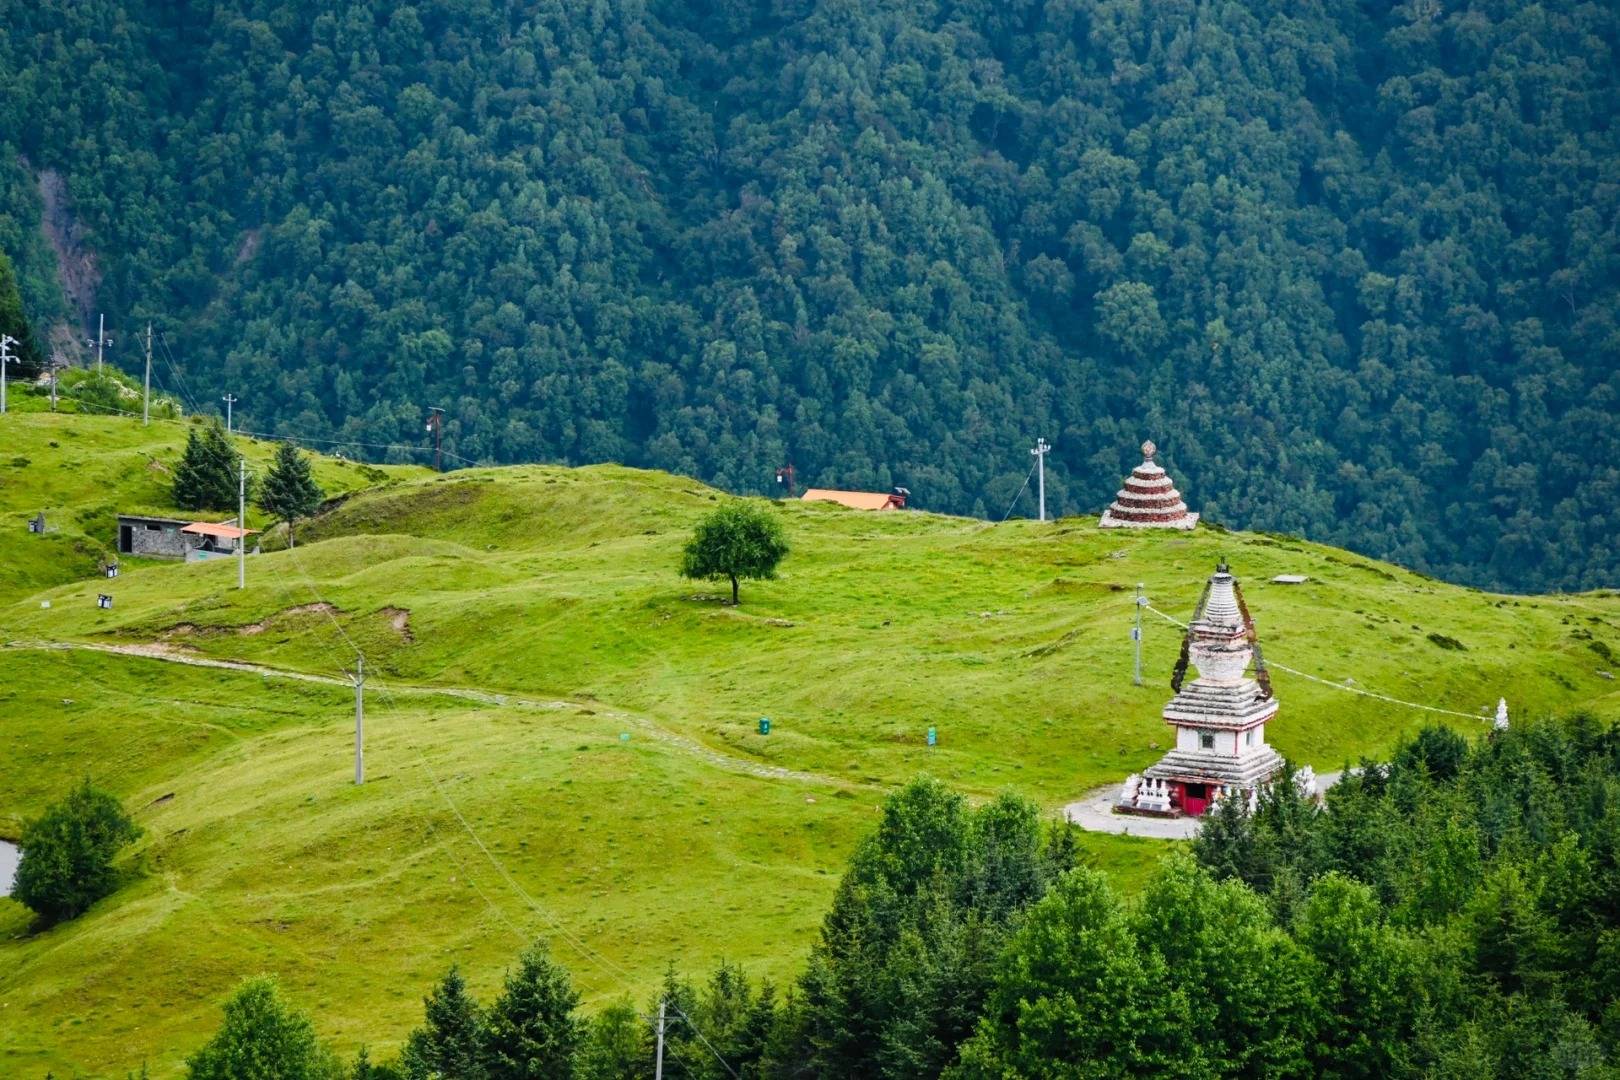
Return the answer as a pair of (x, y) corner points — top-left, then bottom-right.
(11, 780), (141, 921)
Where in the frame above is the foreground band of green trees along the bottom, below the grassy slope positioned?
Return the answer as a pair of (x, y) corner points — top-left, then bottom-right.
(157, 717), (1620, 1080)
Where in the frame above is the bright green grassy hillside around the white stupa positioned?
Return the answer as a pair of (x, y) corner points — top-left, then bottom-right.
(0, 409), (1620, 1075)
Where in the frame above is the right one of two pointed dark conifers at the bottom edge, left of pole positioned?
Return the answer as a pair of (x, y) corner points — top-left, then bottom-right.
(484, 944), (585, 1080)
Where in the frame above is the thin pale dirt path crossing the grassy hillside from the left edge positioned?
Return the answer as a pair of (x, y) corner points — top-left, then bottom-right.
(5, 641), (848, 787)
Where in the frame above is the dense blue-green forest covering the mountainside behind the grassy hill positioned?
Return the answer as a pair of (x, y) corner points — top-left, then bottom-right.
(0, 0), (1620, 589)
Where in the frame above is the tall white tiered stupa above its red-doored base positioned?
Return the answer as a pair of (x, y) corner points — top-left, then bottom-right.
(1144, 562), (1283, 789)
